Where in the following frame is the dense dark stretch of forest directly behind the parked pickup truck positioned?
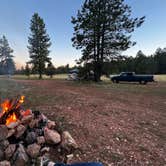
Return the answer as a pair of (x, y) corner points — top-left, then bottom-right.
(103, 48), (166, 75)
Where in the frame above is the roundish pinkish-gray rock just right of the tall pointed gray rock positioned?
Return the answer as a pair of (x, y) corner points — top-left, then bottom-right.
(27, 143), (41, 158)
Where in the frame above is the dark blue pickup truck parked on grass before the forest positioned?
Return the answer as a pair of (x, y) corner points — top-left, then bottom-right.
(111, 72), (154, 84)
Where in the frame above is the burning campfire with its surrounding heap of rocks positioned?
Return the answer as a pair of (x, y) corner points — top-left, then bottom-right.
(0, 96), (78, 166)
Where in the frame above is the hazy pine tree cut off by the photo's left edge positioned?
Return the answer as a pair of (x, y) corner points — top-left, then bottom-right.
(0, 36), (15, 74)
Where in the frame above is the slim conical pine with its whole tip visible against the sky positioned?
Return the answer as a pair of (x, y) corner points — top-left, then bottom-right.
(28, 13), (51, 79)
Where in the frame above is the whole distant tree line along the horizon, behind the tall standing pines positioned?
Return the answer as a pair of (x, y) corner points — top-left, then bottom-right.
(15, 48), (166, 78)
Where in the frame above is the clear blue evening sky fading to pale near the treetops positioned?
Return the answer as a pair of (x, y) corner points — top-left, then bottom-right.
(0, 0), (166, 66)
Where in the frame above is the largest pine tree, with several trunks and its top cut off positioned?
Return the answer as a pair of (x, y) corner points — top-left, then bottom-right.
(72, 0), (145, 81)
